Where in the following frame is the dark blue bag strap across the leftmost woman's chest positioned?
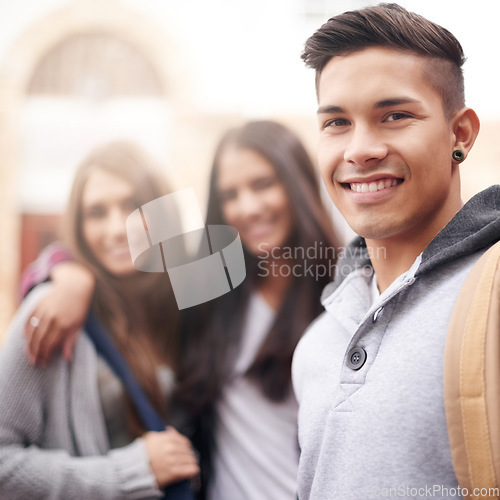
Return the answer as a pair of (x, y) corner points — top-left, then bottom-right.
(85, 311), (195, 500)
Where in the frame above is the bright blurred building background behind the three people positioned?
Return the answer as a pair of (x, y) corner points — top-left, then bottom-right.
(0, 0), (500, 338)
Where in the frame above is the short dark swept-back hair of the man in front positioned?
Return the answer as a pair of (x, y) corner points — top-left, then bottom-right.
(302, 3), (465, 117)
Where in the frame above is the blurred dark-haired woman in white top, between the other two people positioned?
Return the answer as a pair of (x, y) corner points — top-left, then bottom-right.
(178, 121), (337, 500)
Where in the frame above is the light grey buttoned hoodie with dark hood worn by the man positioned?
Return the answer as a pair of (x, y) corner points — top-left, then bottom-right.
(292, 186), (500, 500)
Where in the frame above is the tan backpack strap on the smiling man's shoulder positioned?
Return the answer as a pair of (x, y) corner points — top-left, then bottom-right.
(444, 242), (500, 499)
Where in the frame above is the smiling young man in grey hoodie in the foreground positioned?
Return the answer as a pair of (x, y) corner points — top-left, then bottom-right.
(293, 4), (500, 500)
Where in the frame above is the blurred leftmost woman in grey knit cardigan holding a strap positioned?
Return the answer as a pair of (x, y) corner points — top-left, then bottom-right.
(0, 143), (198, 500)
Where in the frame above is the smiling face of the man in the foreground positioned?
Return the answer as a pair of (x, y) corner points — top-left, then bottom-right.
(318, 48), (461, 246)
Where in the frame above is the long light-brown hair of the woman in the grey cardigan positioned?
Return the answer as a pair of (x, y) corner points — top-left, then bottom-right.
(64, 142), (180, 436)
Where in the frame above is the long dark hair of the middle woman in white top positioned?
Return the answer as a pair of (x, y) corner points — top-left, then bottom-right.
(180, 121), (337, 408)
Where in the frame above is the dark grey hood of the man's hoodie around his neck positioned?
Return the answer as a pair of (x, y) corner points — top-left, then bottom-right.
(321, 185), (500, 300)
